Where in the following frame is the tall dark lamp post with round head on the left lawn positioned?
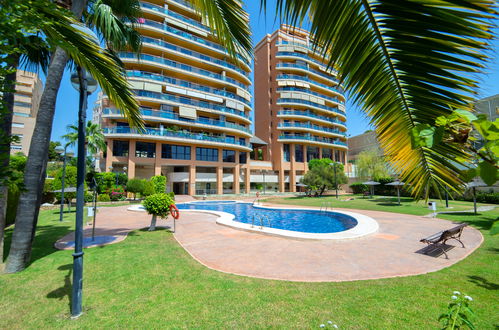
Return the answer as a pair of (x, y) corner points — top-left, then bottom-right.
(71, 24), (99, 318)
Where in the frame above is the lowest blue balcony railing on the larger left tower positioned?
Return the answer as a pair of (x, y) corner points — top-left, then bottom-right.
(103, 126), (249, 148)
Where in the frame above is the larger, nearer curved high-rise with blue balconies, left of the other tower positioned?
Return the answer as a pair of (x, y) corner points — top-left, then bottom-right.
(94, 0), (252, 194)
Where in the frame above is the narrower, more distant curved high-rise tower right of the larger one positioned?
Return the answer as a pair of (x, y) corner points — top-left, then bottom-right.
(254, 25), (348, 192)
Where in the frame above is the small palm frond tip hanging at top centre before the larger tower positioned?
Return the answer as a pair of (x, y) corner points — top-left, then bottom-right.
(190, 0), (253, 59)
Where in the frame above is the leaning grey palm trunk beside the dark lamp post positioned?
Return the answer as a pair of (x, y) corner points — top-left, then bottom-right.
(5, 0), (86, 273)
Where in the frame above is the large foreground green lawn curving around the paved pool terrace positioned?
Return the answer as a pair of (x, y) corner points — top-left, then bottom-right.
(0, 206), (499, 329)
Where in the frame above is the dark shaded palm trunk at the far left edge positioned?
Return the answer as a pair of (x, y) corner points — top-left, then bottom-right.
(0, 56), (19, 272)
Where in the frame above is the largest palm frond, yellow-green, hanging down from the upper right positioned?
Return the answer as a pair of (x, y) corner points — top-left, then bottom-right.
(272, 0), (497, 197)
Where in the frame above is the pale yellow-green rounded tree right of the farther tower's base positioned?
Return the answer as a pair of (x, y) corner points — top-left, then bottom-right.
(355, 150), (390, 181)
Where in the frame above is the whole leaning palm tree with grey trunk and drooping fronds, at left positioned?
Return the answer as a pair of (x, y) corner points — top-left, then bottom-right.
(5, 0), (143, 273)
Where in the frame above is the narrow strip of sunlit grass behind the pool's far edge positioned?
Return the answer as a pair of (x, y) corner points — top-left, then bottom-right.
(263, 195), (487, 215)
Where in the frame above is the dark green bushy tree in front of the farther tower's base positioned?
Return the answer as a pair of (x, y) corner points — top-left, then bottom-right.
(301, 158), (348, 196)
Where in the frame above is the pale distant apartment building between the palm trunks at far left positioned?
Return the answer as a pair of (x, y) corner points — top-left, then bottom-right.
(10, 70), (43, 155)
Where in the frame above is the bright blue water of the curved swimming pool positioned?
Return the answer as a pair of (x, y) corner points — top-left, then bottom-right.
(177, 201), (357, 234)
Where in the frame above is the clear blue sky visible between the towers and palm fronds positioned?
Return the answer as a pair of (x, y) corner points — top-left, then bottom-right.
(47, 0), (499, 147)
